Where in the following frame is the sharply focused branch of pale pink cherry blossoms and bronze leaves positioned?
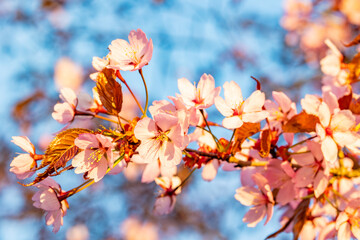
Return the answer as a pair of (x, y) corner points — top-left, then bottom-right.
(10, 29), (360, 239)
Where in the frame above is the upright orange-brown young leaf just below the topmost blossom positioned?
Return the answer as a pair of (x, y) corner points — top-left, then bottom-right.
(96, 68), (123, 116)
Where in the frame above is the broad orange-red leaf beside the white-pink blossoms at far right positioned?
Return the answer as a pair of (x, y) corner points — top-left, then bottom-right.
(283, 112), (320, 133)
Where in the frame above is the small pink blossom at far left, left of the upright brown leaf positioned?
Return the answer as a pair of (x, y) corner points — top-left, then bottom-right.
(52, 88), (78, 124)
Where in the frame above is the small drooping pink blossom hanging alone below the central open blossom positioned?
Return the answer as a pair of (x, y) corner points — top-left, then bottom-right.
(154, 176), (181, 215)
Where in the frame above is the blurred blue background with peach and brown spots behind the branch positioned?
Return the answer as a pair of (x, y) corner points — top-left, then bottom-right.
(0, 0), (360, 240)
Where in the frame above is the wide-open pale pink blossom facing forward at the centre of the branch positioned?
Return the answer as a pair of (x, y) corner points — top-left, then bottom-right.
(134, 113), (188, 167)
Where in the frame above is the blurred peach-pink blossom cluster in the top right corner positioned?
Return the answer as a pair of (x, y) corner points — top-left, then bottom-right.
(280, 0), (360, 65)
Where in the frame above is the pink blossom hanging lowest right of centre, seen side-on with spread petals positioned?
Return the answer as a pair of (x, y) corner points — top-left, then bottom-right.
(235, 173), (275, 227)
